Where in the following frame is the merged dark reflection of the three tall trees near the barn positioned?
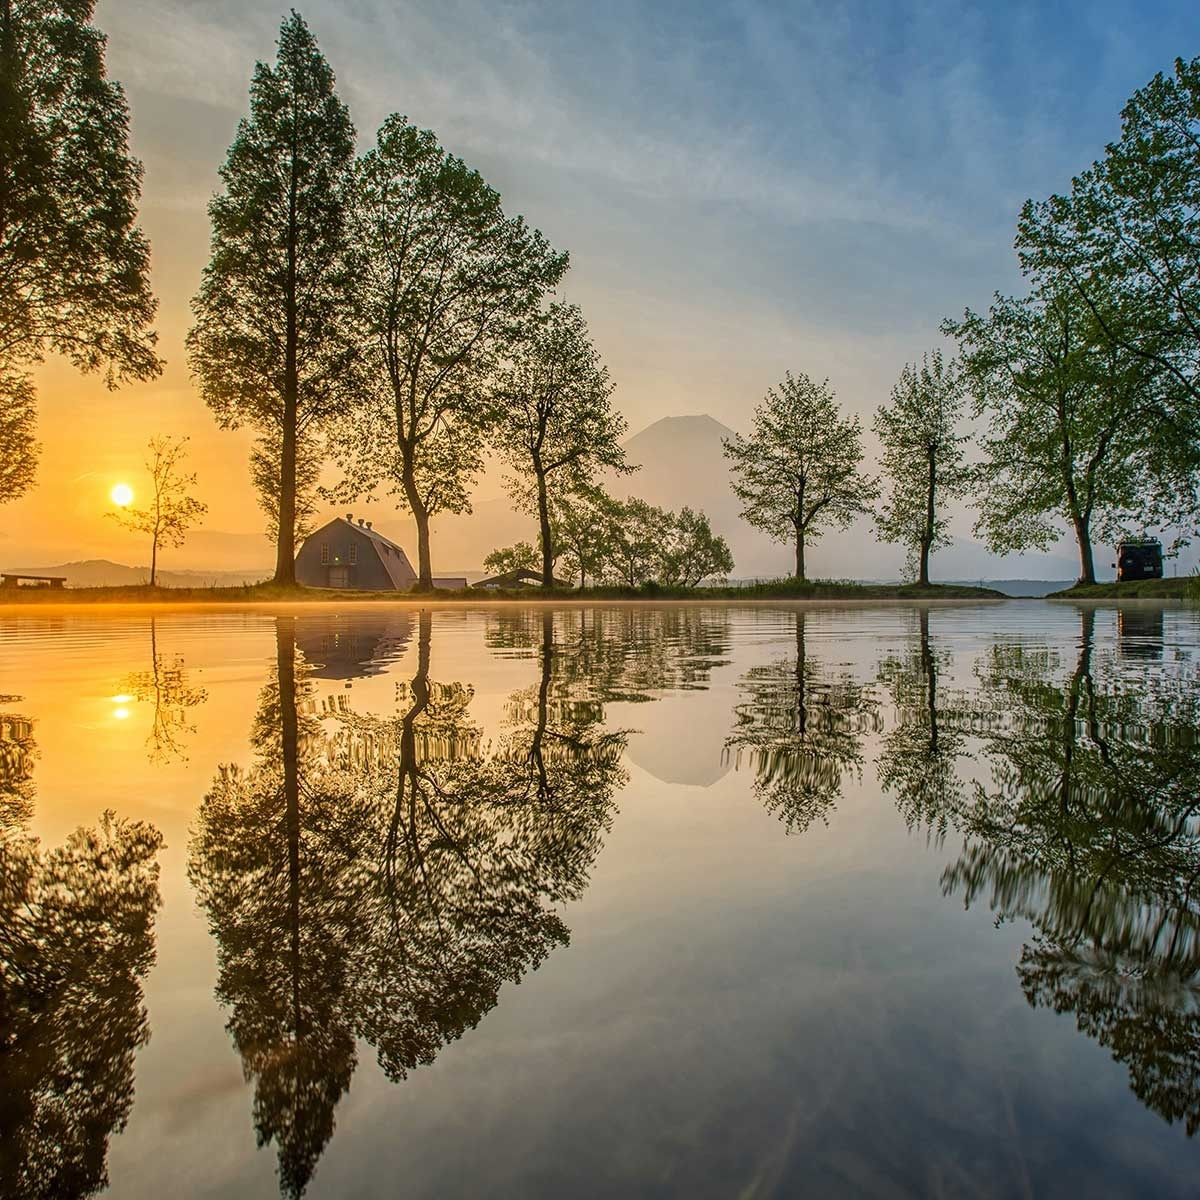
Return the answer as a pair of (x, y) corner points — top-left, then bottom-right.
(190, 611), (624, 1195)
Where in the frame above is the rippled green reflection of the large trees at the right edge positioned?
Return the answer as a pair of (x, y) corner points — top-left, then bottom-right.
(943, 610), (1200, 1135)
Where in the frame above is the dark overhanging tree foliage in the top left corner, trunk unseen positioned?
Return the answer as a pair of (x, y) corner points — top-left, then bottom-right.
(0, 0), (161, 502)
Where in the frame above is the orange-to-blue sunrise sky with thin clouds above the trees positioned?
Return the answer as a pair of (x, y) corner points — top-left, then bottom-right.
(0, 0), (1200, 577)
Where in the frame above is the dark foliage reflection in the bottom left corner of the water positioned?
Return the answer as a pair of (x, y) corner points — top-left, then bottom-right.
(0, 812), (162, 1200)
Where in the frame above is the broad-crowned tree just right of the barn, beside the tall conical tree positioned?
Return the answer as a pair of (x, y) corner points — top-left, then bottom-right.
(335, 115), (566, 592)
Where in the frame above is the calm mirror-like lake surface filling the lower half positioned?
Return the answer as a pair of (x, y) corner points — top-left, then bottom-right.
(0, 601), (1200, 1198)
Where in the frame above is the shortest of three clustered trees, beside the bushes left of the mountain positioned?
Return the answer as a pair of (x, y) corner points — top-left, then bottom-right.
(492, 304), (636, 587)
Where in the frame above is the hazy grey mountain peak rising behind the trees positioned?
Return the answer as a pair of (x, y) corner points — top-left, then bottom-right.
(605, 415), (790, 578)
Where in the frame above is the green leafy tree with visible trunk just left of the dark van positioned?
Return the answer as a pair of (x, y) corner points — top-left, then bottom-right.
(943, 288), (1177, 583)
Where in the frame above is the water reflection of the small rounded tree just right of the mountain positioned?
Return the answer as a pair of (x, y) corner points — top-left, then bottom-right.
(725, 610), (880, 833)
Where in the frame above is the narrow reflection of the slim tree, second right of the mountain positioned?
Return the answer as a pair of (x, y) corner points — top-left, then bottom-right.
(876, 608), (964, 834)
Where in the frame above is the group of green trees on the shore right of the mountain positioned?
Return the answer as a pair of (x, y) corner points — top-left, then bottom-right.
(726, 58), (1200, 583)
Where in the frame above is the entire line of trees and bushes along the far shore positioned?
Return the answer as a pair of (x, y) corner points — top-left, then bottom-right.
(9, 7), (1200, 589)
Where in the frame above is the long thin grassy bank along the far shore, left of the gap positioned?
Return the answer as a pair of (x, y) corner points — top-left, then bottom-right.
(0, 580), (1006, 605)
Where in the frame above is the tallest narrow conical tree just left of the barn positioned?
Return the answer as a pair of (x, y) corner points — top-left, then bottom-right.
(187, 12), (356, 584)
